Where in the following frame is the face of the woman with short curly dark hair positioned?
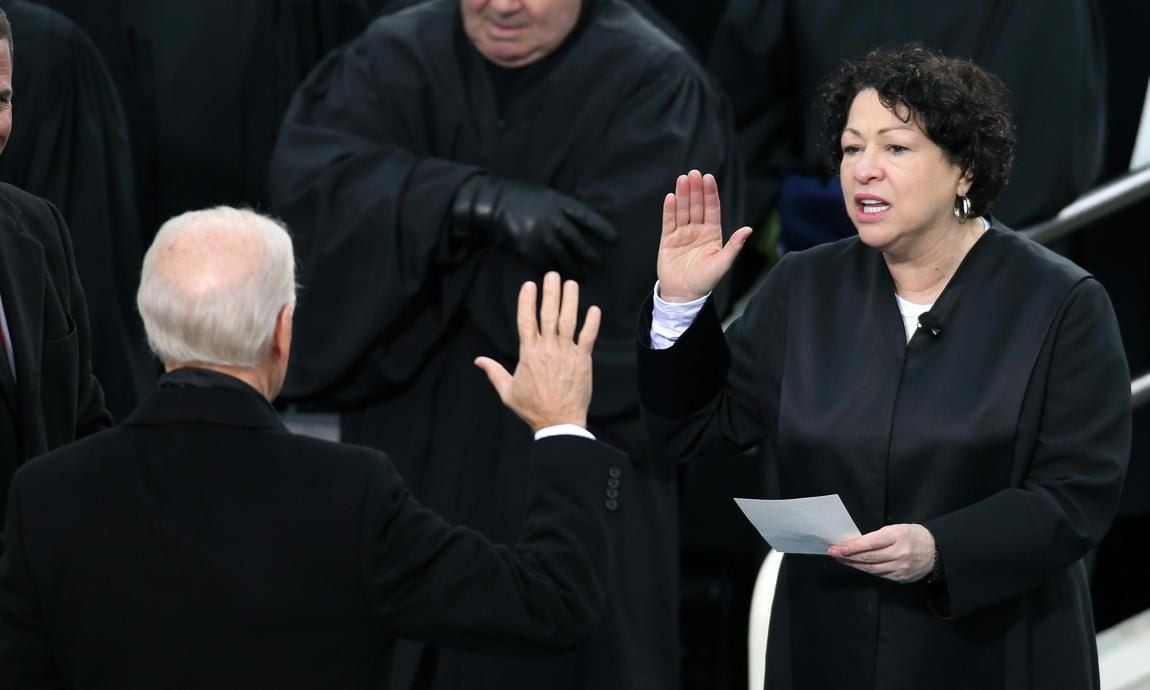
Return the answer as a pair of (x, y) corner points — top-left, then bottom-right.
(838, 89), (971, 254)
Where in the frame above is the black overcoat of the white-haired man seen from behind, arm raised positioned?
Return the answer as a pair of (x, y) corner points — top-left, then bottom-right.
(0, 369), (629, 690)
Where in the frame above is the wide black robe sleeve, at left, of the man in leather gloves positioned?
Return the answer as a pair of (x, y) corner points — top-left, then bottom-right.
(269, 32), (477, 405)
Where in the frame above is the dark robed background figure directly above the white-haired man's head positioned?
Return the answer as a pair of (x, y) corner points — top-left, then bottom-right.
(32, 0), (391, 234)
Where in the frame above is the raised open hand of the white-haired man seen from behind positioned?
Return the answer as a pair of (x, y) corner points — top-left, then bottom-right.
(475, 271), (600, 431)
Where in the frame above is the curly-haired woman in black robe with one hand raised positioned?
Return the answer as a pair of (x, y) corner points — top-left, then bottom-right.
(638, 46), (1130, 690)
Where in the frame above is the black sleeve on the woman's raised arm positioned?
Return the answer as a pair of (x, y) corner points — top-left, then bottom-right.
(638, 255), (791, 458)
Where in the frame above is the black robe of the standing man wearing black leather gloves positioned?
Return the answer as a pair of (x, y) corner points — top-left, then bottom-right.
(270, 0), (741, 690)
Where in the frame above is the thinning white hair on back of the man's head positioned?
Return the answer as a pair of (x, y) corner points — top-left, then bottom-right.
(136, 206), (296, 367)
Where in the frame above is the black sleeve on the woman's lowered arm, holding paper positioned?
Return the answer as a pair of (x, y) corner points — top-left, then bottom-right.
(925, 279), (1130, 618)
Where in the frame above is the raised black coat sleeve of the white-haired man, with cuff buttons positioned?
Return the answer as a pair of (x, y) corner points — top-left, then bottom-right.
(362, 437), (628, 653)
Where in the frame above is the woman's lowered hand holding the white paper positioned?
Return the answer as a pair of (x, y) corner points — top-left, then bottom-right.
(827, 524), (935, 582)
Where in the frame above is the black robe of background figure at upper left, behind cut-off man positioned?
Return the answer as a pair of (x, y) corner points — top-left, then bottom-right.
(0, 0), (153, 419)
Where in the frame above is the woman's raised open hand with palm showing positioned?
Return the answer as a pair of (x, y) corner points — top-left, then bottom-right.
(658, 170), (751, 302)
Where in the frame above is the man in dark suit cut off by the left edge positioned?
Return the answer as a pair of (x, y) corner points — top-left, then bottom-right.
(0, 5), (112, 545)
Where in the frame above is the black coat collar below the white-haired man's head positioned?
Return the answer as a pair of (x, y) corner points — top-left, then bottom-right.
(124, 369), (288, 431)
